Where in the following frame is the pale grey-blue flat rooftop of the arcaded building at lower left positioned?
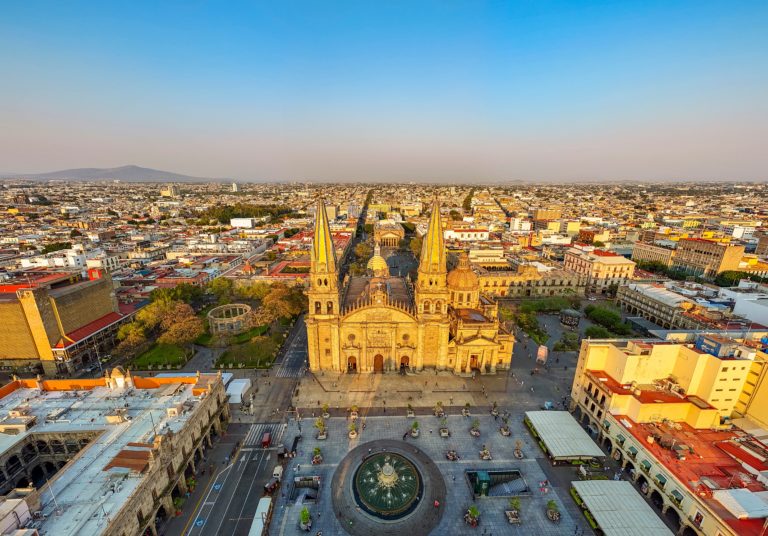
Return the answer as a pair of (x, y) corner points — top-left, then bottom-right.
(0, 369), (218, 534)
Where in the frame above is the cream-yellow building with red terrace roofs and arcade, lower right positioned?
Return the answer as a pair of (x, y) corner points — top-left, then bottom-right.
(571, 333), (768, 536)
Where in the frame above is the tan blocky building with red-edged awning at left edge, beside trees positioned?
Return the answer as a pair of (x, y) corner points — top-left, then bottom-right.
(0, 270), (130, 375)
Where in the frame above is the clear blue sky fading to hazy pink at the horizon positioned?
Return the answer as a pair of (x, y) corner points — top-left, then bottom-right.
(0, 0), (768, 183)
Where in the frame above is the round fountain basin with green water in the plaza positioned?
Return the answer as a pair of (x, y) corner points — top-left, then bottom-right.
(353, 452), (424, 521)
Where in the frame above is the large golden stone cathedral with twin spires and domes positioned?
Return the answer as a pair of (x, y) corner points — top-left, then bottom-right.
(306, 199), (514, 374)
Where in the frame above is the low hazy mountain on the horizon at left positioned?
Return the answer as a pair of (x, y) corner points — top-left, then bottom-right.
(0, 166), (225, 182)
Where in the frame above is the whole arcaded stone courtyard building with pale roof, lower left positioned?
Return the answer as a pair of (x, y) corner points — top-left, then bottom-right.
(0, 368), (229, 536)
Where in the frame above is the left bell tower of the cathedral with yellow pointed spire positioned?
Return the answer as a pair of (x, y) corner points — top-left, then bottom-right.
(306, 200), (340, 371)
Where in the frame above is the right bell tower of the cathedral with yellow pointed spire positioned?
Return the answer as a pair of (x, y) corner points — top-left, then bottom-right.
(414, 198), (450, 370)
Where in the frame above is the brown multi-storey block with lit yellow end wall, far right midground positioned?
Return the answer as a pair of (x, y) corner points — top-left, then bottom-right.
(672, 238), (744, 277)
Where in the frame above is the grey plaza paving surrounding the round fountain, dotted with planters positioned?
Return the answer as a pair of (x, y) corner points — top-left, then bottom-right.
(270, 408), (590, 536)
